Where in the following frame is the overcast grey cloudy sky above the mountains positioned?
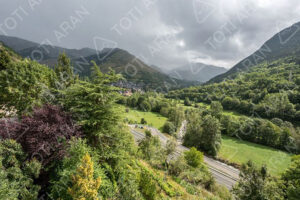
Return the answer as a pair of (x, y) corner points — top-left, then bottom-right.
(0, 0), (300, 70)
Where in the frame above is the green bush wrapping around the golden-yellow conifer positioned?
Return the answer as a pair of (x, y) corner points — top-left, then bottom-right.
(50, 139), (115, 200)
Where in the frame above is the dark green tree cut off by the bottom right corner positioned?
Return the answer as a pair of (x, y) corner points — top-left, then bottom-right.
(282, 155), (300, 200)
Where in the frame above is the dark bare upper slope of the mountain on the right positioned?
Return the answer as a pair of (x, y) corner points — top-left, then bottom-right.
(209, 22), (300, 83)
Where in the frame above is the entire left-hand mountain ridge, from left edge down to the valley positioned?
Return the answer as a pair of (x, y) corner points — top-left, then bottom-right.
(0, 36), (196, 91)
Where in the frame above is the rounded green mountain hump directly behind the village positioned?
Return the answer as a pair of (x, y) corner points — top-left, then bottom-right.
(73, 48), (195, 91)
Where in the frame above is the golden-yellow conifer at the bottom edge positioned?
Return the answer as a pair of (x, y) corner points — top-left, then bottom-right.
(68, 154), (101, 200)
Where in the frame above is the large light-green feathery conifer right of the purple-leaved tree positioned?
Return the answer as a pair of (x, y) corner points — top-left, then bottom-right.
(60, 63), (133, 160)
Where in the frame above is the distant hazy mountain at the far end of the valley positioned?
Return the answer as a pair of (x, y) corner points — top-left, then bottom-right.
(168, 63), (227, 82)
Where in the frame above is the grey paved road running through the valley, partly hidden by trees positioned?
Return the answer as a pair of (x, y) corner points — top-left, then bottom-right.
(129, 125), (239, 189)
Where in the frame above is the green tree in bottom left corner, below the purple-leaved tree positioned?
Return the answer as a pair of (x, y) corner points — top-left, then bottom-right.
(0, 140), (41, 200)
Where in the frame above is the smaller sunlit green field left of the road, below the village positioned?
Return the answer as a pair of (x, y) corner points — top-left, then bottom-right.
(120, 106), (168, 130)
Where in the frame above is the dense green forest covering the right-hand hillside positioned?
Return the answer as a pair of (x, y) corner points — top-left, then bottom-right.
(168, 57), (300, 122)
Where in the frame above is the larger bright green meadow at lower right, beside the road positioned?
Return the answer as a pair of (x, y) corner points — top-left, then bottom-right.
(218, 136), (292, 175)
